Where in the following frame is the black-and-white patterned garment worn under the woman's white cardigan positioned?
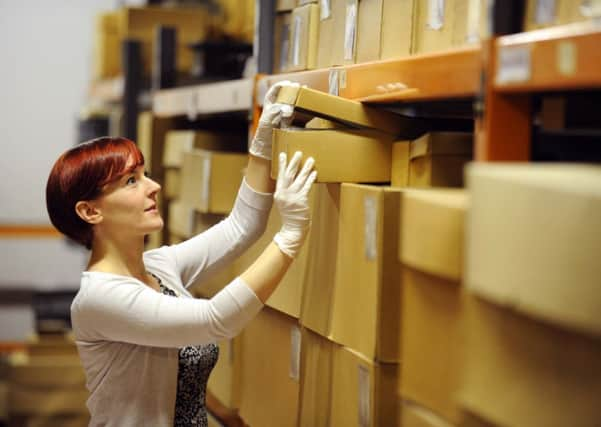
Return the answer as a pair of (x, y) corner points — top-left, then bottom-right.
(150, 273), (219, 427)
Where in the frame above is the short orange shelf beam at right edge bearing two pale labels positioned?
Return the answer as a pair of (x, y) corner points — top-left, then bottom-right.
(493, 21), (601, 93)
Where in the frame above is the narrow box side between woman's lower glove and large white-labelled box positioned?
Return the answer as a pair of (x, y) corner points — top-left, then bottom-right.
(300, 184), (340, 337)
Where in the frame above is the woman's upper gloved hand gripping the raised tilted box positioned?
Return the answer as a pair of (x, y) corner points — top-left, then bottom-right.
(248, 80), (300, 160)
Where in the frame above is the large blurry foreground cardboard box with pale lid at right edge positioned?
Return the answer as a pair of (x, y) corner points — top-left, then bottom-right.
(461, 164), (601, 426)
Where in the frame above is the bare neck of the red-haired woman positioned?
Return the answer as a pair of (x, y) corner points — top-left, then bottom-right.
(87, 234), (146, 281)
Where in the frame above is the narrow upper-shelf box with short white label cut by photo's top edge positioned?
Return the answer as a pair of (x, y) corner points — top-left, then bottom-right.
(317, 0), (348, 68)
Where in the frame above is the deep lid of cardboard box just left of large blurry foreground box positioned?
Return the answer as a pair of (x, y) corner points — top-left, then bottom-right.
(399, 189), (469, 281)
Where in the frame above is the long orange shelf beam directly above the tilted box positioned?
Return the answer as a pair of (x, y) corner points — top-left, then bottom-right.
(257, 46), (482, 103)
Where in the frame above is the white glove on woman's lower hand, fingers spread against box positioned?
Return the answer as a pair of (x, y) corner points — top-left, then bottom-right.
(273, 151), (317, 258)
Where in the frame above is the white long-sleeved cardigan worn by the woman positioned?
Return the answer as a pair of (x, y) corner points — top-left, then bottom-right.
(71, 181), (272, 427)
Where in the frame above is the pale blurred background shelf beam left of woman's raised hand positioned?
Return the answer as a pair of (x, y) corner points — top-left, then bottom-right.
(152, 78), (254, 119)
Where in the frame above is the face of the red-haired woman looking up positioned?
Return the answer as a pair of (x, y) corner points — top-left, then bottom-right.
(92, 159), (163, 241)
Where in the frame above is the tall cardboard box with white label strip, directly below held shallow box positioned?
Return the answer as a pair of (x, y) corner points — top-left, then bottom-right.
(330, 183), (402, 362)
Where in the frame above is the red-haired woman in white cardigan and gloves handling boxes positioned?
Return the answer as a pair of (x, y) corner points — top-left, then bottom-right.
(46, 82), (316, 427)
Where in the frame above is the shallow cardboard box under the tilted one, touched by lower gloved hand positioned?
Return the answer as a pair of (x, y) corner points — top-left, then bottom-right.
(271, 129), (392, 182)
